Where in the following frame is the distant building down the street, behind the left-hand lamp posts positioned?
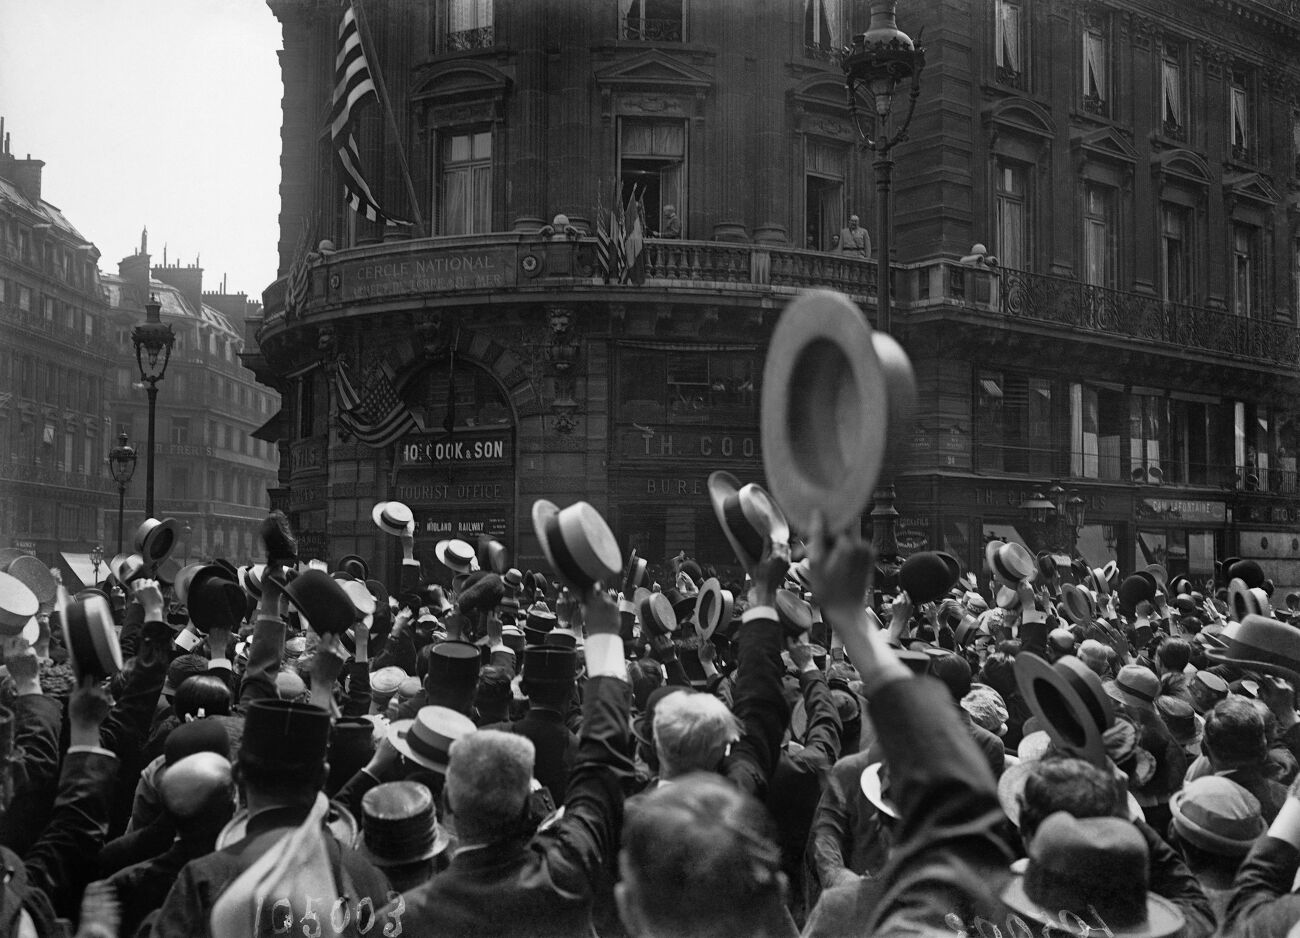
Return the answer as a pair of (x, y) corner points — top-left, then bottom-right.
(101, 239), (280, 560)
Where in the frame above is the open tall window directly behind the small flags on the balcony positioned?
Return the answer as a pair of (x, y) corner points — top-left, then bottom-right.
(619, 118), (690, 238)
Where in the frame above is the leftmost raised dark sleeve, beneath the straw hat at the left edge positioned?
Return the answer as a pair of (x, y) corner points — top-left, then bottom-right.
(0, 694), (64, 856)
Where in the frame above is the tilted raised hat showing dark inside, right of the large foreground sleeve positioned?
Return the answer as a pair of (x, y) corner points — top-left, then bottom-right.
(1015, 652), (1114, 767)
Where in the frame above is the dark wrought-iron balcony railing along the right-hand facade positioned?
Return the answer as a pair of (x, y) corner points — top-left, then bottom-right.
(1001, 269), (1300, 368)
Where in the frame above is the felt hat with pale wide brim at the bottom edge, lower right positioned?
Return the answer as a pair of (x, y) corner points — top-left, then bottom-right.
(1002, 811), (1186, 938)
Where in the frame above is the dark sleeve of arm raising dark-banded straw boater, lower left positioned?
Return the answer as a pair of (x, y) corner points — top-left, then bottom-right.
(23, 751), (118, 917)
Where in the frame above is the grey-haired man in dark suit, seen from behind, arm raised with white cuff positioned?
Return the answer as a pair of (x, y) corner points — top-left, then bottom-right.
(402, 592), (633, 938)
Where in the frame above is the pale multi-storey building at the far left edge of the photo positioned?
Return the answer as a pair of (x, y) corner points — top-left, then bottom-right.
(0, 121), (117, 574)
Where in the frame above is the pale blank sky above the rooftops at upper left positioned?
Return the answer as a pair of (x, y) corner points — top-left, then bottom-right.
(0, 0), (282, 299)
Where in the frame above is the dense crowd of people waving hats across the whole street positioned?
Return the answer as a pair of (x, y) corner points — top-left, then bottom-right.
(0, 483), (1300, 938)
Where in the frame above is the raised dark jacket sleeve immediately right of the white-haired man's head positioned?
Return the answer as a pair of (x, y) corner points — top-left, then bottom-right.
(727, 617), (789, 800)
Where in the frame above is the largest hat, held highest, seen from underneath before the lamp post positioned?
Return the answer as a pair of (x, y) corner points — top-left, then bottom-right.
(761, 290), (911, 534)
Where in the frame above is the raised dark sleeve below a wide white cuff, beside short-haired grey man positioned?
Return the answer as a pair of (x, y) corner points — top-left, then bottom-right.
(534, 677), (633, 887)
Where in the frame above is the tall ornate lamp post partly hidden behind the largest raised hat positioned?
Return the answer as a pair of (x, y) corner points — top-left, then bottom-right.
(844, 0), (926, 557)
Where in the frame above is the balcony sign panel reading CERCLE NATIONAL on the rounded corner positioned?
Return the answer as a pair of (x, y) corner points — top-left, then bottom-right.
(332, 246), (516, 300)
